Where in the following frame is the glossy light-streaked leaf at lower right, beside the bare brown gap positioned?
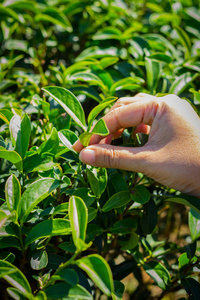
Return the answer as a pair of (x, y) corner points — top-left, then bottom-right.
(144, 261), (171, 290)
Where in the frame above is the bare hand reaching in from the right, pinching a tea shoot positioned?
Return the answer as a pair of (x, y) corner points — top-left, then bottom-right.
(73, 94), (200, 197)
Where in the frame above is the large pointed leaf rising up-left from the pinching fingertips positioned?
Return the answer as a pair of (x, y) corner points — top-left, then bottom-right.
(42, 86), (86, 131)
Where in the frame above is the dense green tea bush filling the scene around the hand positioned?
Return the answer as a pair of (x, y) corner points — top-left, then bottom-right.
(0, 0), (200, 300)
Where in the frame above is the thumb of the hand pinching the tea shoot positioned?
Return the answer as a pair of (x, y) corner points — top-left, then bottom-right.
(79, 144), (153, 173)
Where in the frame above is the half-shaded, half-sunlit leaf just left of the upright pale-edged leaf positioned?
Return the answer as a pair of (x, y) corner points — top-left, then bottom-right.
(25, 219), (71, 246)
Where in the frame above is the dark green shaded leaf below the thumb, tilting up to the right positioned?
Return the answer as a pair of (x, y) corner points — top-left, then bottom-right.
(102, 191), (132, 212)
